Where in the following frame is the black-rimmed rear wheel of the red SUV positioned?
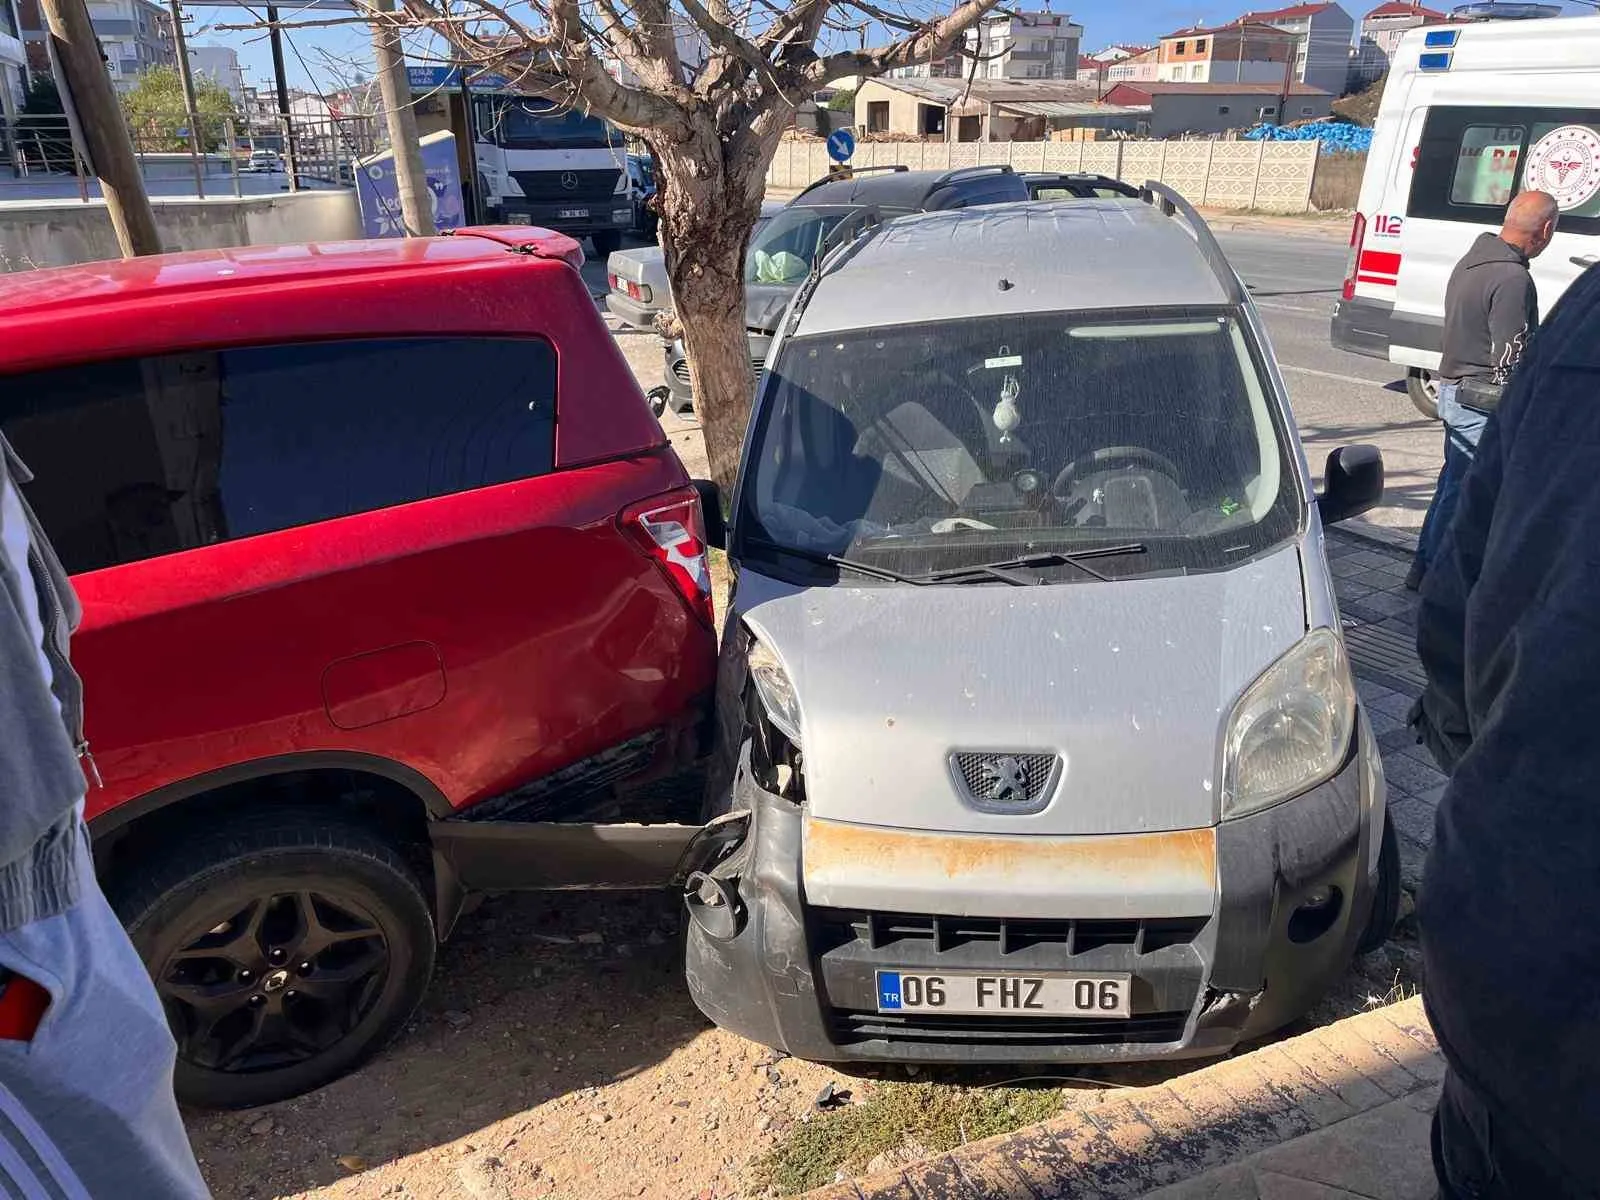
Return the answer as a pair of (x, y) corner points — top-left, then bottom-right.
(109, 810), (435, 1109)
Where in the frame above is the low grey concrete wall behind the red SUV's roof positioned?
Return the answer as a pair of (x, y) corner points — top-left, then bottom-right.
(0, 190), (362, 270)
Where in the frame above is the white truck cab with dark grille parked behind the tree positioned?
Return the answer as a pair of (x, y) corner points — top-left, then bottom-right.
(472, 88), (634, 258)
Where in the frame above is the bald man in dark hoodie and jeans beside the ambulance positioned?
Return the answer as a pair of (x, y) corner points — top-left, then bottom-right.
(1406, 192), (1558, 590)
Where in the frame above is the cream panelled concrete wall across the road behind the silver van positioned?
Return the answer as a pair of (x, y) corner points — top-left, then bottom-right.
(766, 141), (1318, 213)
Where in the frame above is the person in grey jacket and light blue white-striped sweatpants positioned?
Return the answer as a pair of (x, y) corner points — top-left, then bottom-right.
(0, 435), (206, 1200)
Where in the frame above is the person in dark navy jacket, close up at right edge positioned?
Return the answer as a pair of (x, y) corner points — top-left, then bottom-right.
(1416, 262), (1600, 1200)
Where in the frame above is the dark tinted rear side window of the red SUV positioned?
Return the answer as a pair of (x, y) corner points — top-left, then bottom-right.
(0, 338), (555, 574)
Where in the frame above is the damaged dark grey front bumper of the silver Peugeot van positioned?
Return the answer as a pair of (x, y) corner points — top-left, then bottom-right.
(685, 722), (1384, 1062)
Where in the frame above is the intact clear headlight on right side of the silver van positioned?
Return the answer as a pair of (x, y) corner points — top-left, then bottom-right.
(1222, 629), (1355, 821)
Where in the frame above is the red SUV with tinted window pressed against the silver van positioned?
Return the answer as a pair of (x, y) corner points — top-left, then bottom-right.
(0, 229), (715, 1106)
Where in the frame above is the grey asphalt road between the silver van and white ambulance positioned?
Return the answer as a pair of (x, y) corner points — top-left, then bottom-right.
(1218, 227), (1443, 533)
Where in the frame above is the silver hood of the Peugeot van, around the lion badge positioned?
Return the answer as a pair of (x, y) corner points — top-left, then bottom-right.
(736, 544), (1306, 835)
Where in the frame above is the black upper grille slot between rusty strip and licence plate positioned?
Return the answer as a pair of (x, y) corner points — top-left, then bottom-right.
(816, 909), (1210, 955)
